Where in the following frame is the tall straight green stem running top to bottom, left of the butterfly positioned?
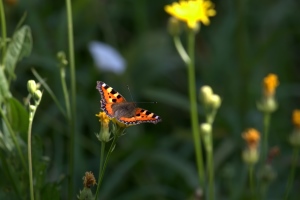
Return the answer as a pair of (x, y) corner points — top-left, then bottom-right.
(66, 0), (76, 200)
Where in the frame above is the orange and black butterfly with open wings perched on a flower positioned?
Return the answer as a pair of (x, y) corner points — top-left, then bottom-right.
(96, 81), (161, 125)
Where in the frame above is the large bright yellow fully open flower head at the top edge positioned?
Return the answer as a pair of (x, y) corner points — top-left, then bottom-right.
(165, 0), (216, 29)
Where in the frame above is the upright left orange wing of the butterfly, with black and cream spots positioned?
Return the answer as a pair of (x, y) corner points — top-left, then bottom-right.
(96, 81), (126, 117)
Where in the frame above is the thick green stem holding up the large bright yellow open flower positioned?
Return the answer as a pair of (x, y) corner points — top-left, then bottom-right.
(186, 30), (205, 187)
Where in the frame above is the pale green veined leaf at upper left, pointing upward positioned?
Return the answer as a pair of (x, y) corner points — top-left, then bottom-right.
(4, 25), (32, 78)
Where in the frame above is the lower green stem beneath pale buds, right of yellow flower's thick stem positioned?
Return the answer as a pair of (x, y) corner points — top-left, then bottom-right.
(206, 148), (214, 200)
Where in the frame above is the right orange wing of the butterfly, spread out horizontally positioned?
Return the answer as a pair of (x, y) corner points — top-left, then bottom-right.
(118, 108), (161, 125)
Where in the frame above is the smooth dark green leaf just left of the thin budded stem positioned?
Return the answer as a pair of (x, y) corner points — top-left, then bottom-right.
(7, 97), (29, 133)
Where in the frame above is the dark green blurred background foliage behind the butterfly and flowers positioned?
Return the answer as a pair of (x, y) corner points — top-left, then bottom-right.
(0, 0), (300, 200)
